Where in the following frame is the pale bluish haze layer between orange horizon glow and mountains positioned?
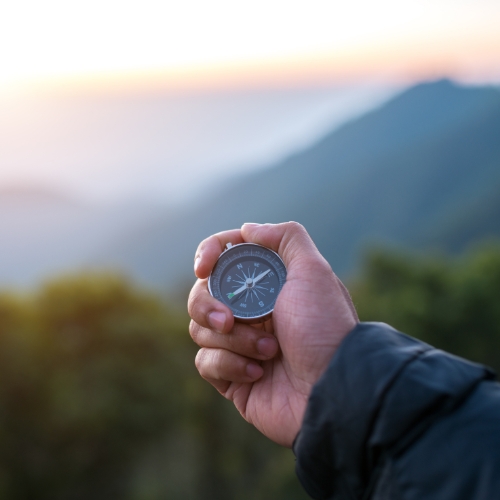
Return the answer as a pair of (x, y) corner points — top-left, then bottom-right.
(0, 85), (394, 203)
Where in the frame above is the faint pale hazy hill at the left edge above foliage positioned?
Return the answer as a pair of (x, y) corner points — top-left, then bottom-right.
(0, 187), (161, 286)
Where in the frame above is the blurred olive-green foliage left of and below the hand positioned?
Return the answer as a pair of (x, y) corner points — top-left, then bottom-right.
(0, 275), (306, 500)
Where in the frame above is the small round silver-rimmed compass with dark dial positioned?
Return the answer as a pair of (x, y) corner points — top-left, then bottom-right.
(208, 243), (286, 323)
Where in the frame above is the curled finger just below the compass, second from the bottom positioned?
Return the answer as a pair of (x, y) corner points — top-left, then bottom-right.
(189, 321), (279, 360)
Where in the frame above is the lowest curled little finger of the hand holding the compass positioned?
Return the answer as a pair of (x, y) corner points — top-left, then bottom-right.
(195, 348), (264, 394)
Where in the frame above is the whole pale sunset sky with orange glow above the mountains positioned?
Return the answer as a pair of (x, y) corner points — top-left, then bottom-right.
(0, 0), (500, 201)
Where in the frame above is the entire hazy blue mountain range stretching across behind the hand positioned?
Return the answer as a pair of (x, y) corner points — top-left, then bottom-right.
(0, 80), (500, 292)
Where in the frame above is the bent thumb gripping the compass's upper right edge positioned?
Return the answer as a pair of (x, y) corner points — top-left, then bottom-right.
(241, 222), (323, 267)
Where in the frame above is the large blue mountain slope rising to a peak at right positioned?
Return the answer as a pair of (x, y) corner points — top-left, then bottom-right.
(99, 80), (500, 287)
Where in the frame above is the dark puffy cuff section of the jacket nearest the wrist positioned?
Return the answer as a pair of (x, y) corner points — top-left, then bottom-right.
(293, 323), (494, 500)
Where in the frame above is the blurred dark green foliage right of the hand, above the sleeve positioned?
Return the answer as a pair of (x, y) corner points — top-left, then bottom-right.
(350, 243), (500, 372)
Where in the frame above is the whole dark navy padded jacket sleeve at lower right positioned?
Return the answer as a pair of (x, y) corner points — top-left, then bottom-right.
(294, 323), (500, 500)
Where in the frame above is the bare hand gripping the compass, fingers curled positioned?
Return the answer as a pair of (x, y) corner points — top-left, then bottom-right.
(188, 222), (358, 447)
